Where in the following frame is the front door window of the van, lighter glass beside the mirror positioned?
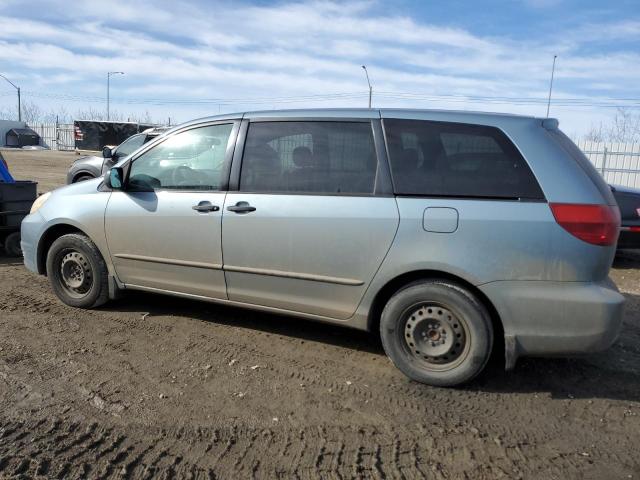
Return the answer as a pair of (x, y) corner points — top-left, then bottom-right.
(129, 123), (233, 190)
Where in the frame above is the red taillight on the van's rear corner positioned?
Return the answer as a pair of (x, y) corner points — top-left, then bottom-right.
(549, 203), (620, 246)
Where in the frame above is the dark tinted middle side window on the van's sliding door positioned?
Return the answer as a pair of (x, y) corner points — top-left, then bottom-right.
(240, 122), (377, 194)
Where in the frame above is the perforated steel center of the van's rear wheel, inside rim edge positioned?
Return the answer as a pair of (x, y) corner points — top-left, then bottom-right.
(404, 305), (466, 363)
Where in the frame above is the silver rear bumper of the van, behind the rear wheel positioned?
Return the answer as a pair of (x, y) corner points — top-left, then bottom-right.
(480, 280), (624, 360)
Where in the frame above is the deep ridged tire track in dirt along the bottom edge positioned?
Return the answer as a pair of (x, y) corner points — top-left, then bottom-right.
(0, 414), (637, 479)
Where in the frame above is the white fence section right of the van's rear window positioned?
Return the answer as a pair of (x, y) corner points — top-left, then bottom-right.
(576, 141), (640, 188)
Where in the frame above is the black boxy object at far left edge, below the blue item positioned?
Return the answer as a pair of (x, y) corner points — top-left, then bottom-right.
(0, 180), (38, 257)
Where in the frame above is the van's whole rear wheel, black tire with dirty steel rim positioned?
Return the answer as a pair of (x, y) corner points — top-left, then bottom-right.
(380, 280), (493, 387)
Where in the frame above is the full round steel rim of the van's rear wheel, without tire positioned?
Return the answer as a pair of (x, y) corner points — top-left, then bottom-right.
(399, 302), (471, 371)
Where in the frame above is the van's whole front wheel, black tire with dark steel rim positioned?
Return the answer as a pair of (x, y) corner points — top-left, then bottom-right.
(47, 233), (109, 308)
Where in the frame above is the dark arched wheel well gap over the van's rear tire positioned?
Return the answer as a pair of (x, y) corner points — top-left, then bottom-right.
(367, 270), (504, 352)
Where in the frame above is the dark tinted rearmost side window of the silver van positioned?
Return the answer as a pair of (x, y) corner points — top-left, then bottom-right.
(384, 119), (544, 200)
